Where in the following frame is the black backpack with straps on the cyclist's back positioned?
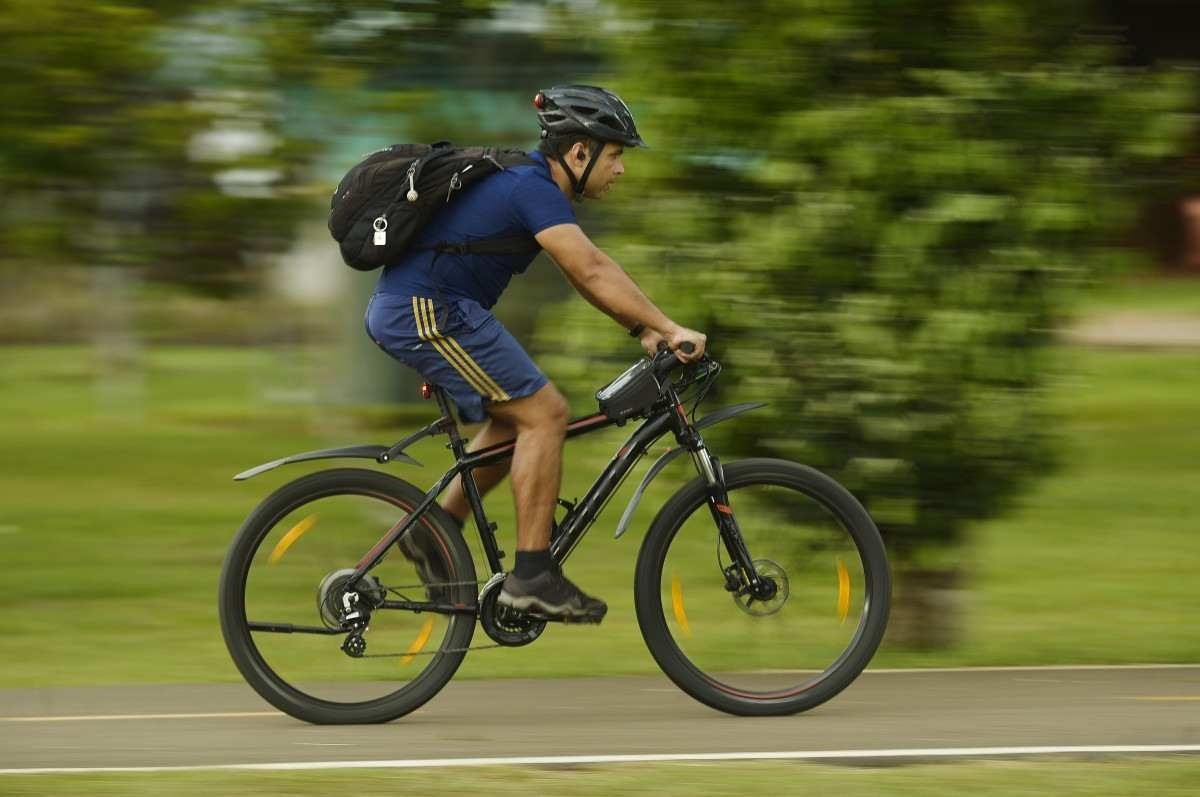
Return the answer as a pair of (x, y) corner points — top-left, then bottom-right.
(329, 142), (540, 271)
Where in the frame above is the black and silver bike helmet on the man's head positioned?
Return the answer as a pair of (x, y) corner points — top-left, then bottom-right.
(533, 85), (646, 146)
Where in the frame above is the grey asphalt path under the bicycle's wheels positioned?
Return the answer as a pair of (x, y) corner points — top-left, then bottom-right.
(0, 666), (1200, 769)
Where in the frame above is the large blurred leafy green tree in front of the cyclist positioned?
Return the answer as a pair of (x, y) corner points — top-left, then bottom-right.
(553, 0), (1196, 646)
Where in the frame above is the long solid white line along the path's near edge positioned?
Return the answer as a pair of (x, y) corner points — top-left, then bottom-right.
(0, 744), (1200, 775)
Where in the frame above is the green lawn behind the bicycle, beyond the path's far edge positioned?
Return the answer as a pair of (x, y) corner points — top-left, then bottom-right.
(0, 338), (1200, 687)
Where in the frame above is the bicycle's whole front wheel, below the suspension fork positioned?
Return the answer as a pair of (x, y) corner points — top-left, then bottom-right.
(635, 460), (892, 715)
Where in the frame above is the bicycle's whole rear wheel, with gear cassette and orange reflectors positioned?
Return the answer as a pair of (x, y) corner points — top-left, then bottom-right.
(220, 468), (476, 724)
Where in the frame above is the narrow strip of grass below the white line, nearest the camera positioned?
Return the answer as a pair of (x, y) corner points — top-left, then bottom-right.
(0, 757), (1200, 797)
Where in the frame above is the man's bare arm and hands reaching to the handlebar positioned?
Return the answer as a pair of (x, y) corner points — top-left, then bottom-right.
(535, 224), (706, 360)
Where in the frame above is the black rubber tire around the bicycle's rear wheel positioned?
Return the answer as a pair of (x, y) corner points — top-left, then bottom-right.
(218, 468), (475, 725)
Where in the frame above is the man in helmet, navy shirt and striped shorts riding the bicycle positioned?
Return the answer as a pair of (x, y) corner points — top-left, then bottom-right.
(366, 85), (706, 622)
